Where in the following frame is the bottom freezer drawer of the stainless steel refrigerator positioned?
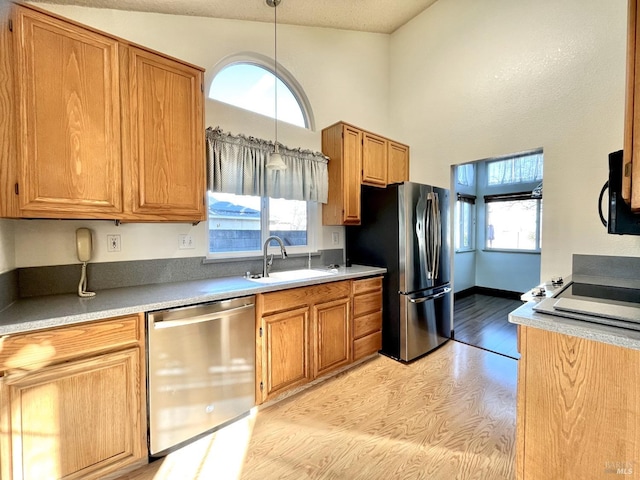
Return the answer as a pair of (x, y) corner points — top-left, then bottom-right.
(400, 286), (453, 361)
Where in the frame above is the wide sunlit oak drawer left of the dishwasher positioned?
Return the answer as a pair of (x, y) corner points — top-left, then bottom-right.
(0, 315), (142, 372)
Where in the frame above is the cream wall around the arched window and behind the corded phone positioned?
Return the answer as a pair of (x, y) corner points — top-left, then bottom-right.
(16, 3), (389, 267)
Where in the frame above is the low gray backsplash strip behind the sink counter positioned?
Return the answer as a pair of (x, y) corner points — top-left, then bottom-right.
(11, 249), (344, 298)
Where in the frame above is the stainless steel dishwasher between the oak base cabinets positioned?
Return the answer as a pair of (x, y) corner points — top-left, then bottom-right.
(147, 296), (255, 456)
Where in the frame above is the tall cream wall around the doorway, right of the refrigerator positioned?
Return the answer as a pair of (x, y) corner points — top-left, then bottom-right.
(390, 0), (640, 279)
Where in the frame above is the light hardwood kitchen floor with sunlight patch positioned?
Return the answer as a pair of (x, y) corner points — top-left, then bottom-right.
(117, 341), (517, 480)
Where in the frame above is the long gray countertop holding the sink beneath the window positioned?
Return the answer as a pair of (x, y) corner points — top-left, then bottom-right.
(0, 265), (386, 335)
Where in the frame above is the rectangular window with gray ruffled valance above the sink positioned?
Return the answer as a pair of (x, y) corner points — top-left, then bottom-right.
(206, 128), (328, 257)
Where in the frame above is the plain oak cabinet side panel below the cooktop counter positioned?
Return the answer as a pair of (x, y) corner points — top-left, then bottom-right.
(516, 325), (640, 480)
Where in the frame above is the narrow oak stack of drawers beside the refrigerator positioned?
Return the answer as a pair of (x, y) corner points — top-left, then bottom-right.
(352, 277), (382, 361)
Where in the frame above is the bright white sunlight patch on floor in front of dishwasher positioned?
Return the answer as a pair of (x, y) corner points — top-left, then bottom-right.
(153, 408), (257, 480)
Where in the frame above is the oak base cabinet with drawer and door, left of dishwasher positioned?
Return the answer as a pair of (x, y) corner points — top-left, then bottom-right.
(0, 315), (147, 480)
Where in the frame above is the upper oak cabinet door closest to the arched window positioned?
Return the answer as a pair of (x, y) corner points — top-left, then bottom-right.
(122, 47), (205, 222)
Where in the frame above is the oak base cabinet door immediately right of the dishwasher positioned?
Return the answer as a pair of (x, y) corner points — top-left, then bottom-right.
(261, 306), (312, 401)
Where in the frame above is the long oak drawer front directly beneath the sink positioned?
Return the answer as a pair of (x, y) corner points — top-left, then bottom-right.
(259, 280), (350, 315)
